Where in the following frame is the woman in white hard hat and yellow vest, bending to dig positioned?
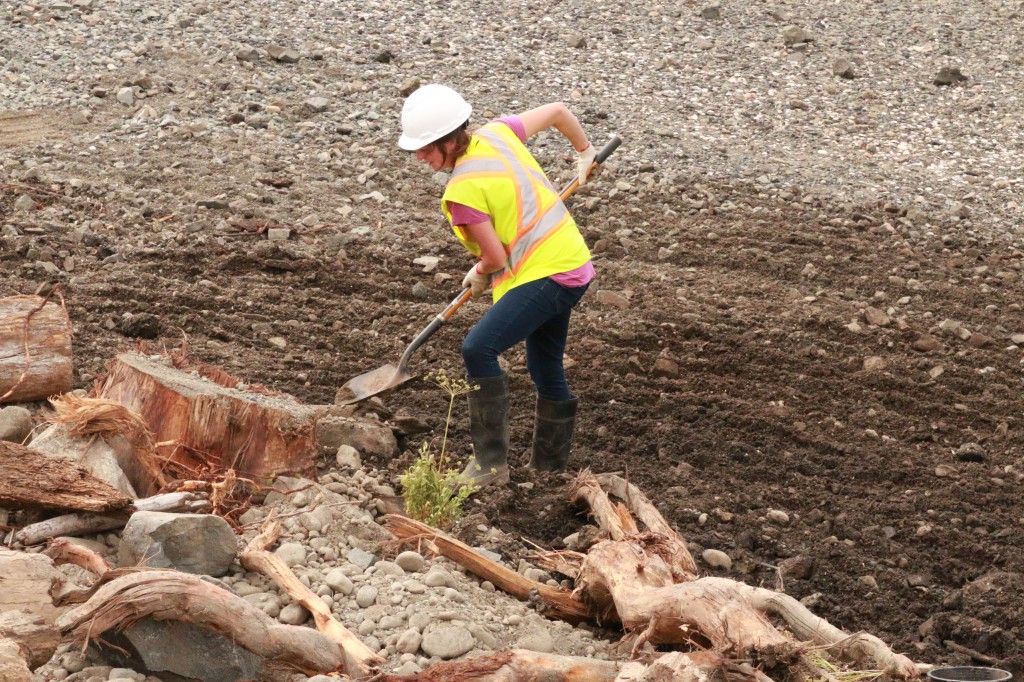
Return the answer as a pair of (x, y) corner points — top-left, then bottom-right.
(398, 84), (596, 487)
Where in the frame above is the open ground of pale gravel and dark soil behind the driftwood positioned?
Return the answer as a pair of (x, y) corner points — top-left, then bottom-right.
(0, 0), (1024, 679)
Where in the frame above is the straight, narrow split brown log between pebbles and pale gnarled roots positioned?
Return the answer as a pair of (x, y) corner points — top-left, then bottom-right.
(384, 514), (594, 623)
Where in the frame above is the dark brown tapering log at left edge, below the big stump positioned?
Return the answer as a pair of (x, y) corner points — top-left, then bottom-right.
(0, 441), (131, 512)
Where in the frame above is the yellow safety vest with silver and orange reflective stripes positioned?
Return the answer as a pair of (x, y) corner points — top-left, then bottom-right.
(441, 122), (590, 302)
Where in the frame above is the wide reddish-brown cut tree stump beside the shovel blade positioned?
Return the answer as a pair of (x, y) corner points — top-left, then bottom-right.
(100, 353), (318, 496)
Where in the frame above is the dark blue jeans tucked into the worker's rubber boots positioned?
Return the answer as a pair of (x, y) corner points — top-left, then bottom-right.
(462, 278), (590, 400)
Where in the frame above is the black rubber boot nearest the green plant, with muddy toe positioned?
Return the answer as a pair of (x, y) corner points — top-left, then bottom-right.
(460, 374), (509, 487)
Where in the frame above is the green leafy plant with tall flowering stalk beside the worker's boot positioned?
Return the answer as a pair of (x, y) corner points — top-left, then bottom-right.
(398, 370), (477, 528)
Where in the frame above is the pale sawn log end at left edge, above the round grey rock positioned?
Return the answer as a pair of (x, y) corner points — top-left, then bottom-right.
(0, 296), (74, 402)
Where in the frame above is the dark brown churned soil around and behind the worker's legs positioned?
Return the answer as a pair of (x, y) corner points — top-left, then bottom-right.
(0, 164), (1024, 674)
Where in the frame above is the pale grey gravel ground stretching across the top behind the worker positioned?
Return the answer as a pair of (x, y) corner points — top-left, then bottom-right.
(0, 0), (1024, 239)
